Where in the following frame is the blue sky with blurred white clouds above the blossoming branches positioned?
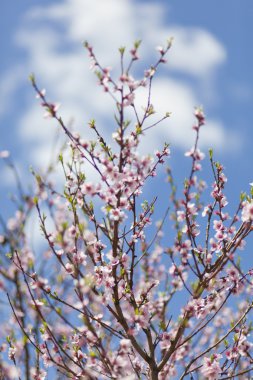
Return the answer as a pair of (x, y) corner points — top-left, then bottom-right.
(0, 0), (253, 220)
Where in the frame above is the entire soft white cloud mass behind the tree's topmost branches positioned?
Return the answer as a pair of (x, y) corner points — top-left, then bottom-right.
(0, 0), (238, 171)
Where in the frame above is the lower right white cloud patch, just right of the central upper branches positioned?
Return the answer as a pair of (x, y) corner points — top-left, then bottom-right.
(133, 78), (240, 152)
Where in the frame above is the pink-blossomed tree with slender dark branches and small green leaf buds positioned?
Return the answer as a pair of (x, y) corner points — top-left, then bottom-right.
(0, 40), (253, 380)
